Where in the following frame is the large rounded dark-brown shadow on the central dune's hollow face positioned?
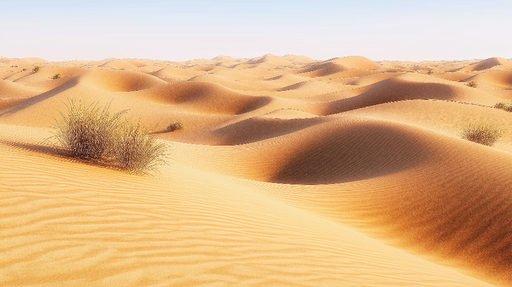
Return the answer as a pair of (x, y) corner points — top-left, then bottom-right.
(270, 124), (431, 184)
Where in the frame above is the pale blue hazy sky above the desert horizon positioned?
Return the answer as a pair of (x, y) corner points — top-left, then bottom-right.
(0, 0), (512, 61)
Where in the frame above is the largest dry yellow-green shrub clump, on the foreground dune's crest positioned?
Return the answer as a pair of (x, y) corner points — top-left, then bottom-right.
(53, 100), (165, 174)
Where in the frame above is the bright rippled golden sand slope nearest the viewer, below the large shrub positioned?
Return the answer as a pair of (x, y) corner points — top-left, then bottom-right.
(0, 129), (491, 286)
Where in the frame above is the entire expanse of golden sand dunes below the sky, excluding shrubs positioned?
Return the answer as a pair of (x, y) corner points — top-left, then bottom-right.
(0, 55), (512, 286)
